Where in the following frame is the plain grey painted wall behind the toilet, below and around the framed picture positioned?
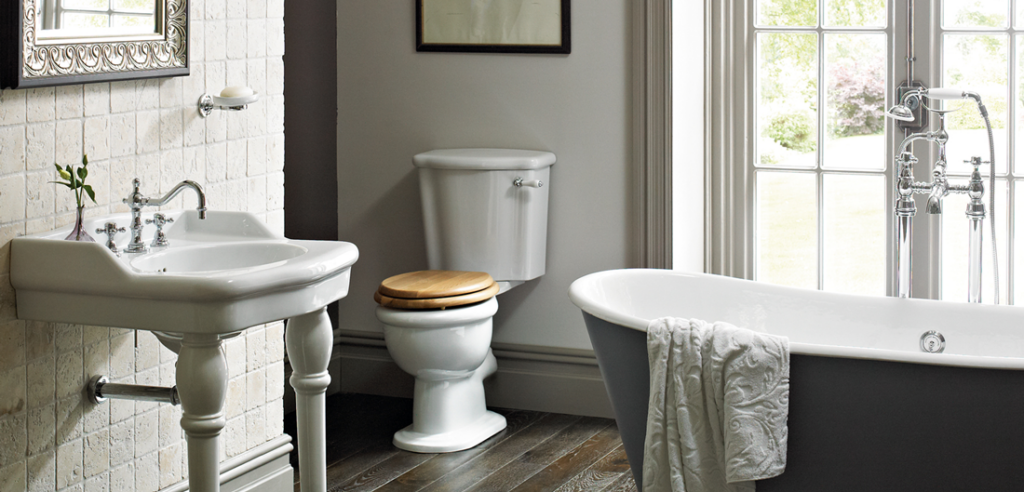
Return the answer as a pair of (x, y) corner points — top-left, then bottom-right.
(339, 0), (631, 350)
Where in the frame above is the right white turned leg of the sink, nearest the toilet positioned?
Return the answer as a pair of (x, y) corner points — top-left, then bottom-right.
(285, 308), (334, 492)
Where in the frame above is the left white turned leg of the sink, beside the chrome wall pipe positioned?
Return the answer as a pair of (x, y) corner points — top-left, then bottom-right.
(176, 334), (227, 492)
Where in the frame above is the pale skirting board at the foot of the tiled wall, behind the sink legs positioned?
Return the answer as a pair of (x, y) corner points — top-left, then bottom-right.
(160, 434), (295, 492)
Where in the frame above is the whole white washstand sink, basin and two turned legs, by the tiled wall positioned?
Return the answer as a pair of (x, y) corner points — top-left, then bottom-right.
(10, 210), (358, 492)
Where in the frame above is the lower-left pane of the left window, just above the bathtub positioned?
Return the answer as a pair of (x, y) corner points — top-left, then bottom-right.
(755, 171), (818, 289)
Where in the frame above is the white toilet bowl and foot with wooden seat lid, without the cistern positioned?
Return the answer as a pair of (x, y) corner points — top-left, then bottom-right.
(374, 272), (506, 453)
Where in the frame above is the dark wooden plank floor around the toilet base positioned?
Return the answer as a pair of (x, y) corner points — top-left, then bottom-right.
(285, 394), (637, 492)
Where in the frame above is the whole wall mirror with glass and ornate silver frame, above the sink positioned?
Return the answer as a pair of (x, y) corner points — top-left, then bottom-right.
(0, 0), (188, 88)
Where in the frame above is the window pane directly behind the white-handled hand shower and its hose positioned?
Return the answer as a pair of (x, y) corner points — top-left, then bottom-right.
(942, 34), (1009, 174)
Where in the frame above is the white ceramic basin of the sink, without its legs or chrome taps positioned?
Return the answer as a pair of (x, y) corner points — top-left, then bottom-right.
(10, 210), (358, 333)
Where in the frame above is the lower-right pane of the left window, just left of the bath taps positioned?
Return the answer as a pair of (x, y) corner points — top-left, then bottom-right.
(822, 174), (886, 295)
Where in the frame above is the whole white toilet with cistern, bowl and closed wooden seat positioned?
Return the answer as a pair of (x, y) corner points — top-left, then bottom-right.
(374, 149), (555, 453)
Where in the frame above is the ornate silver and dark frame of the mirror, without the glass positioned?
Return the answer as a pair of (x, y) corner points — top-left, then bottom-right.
(0, 0), (188, 88)
